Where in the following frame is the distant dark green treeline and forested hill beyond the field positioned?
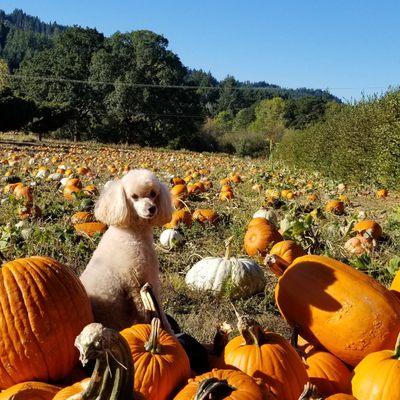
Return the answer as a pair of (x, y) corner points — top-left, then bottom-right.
(0, 10), (340, 155)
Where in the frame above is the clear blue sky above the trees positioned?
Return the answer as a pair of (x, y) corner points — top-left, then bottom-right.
(0, 0), (400, 100)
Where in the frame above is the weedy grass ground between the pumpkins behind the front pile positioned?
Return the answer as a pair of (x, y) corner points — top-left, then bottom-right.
(0, 143), (400, 342)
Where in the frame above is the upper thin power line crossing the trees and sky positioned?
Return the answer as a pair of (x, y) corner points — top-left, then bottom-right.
(9, 74), (391, 91)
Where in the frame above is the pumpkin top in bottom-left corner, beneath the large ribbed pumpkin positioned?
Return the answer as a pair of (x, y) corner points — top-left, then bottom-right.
(0, 382), (60, 400)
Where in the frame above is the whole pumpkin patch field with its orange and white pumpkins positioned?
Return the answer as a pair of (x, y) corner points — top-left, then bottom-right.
(0, 142), (400, 400)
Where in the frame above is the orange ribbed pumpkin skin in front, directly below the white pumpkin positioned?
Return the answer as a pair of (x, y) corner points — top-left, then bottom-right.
(224, 332), (308, 400)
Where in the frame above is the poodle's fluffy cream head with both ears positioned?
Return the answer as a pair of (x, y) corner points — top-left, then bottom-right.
(95, 169), (172, 227)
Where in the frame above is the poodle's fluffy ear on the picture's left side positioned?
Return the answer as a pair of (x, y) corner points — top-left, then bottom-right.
(95, 181), (133, 226)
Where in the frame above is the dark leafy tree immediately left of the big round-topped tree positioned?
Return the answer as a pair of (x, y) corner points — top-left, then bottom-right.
(18, 27), (104, 140)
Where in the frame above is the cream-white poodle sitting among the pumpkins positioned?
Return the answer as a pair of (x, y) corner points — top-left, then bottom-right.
(80, 169), (172, 331)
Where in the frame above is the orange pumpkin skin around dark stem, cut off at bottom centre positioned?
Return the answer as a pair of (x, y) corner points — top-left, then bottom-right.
(174, 369), (264, 400)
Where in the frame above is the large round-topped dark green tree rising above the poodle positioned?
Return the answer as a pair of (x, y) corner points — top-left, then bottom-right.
(91, 31), (203, 147)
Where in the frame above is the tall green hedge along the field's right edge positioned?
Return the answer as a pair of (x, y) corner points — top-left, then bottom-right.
(274, 90), (400, 188)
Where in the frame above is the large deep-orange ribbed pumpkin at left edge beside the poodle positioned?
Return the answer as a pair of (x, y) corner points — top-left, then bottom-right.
(0, 257), (93, 389)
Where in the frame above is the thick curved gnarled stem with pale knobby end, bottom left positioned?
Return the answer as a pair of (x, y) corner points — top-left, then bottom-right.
(75, 323), (134, 400)
